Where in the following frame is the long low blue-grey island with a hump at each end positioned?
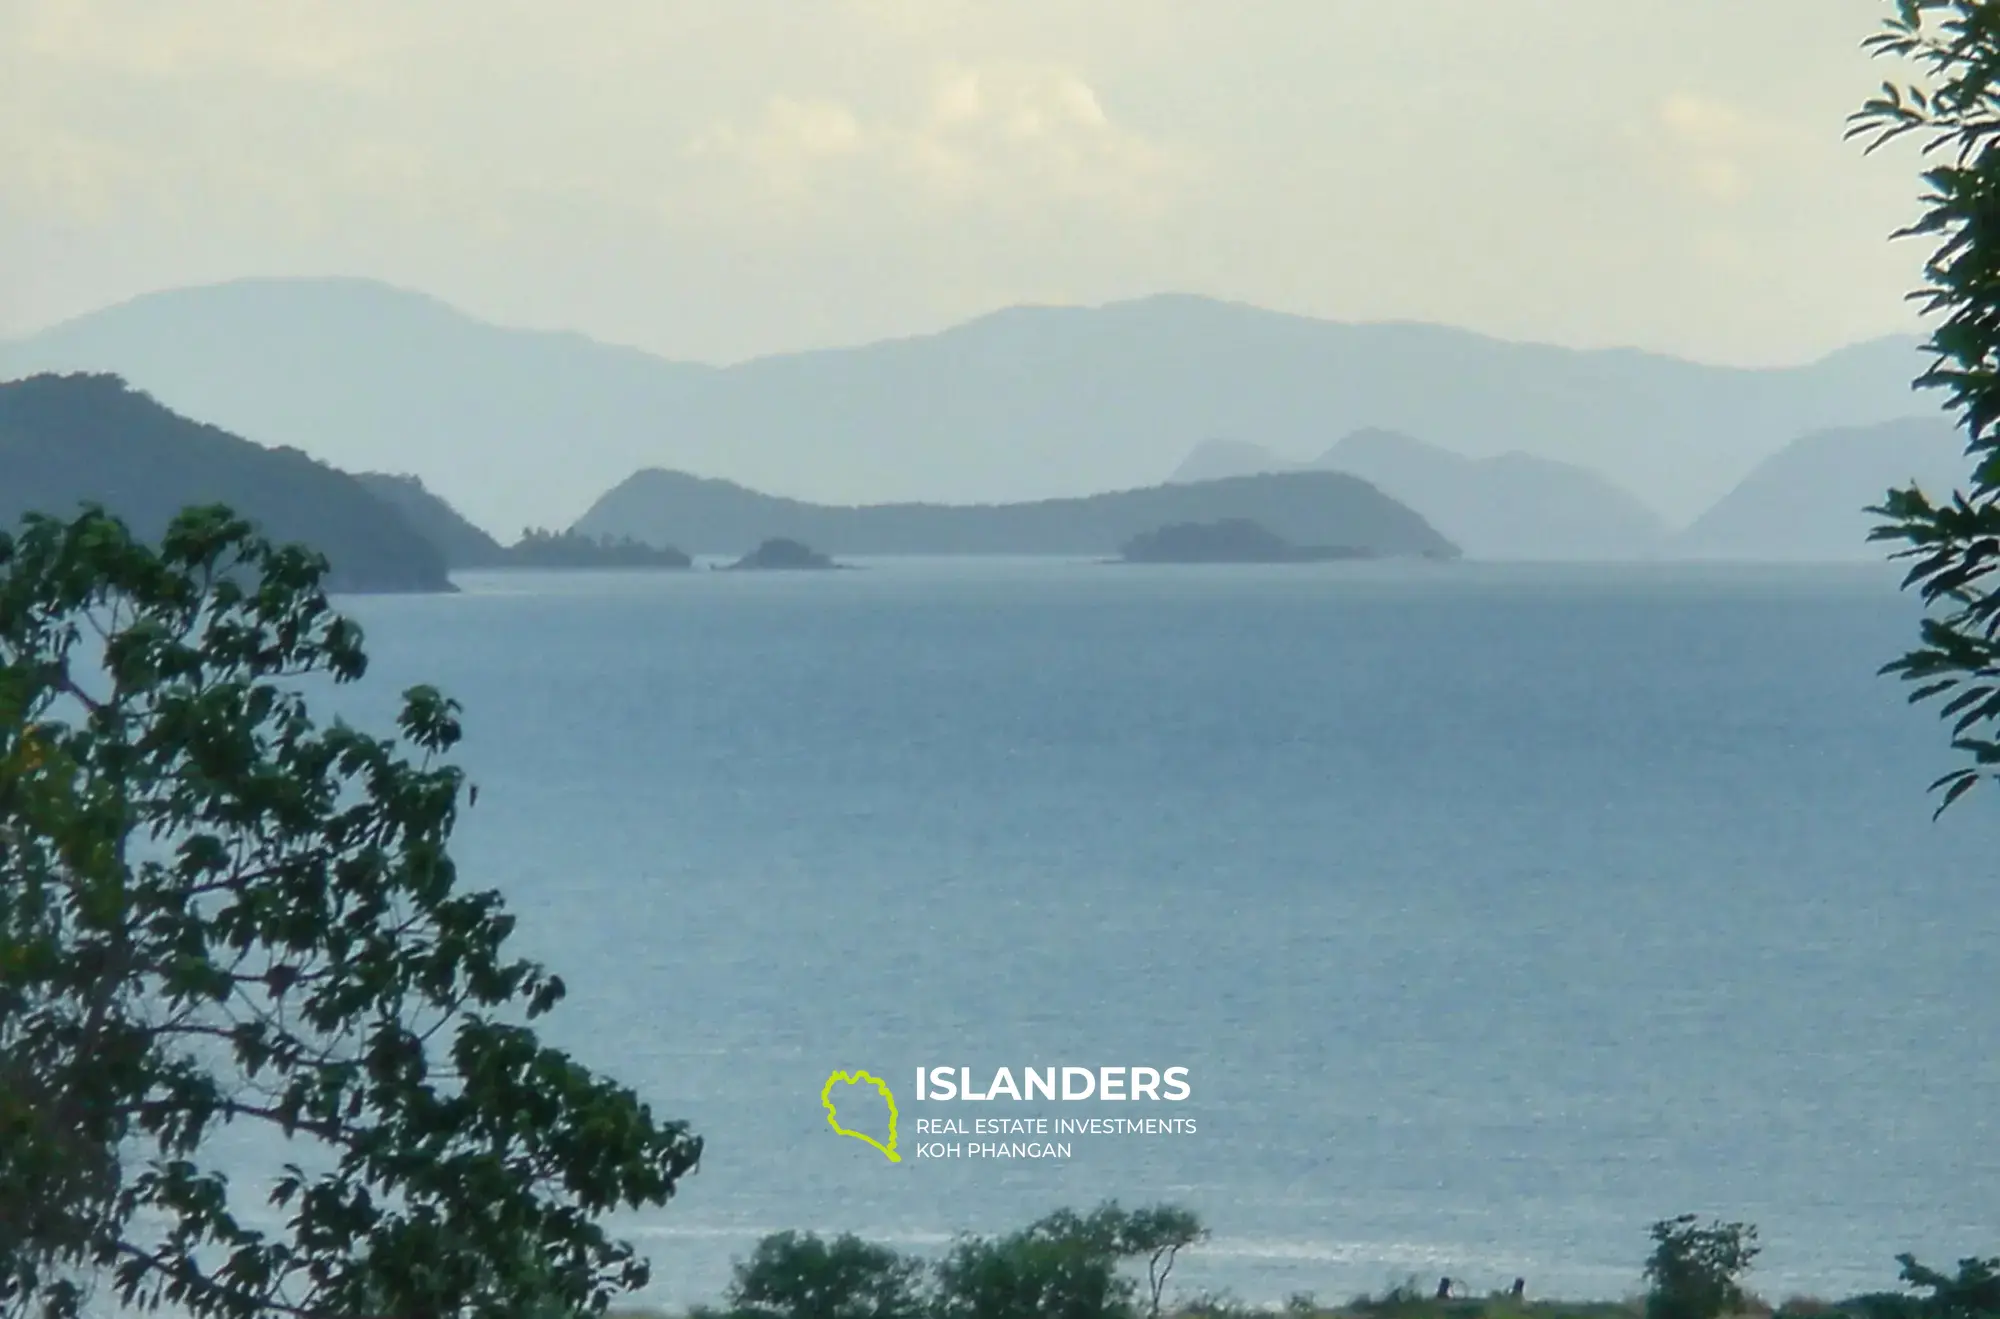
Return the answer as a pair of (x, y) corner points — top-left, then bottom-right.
(576, 470), (1458, 558)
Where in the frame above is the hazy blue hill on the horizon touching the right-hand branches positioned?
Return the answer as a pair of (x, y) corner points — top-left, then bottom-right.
(1666, 418), (1972, 562)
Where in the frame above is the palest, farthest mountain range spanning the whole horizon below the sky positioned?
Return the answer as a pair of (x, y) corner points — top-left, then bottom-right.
(0, 280), (1934, 536)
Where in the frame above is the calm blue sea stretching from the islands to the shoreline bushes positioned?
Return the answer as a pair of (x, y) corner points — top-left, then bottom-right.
(312, 560), (2000, 1305)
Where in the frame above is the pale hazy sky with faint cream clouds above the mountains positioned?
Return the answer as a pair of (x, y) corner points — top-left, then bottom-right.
(0, 0), (1920, 364)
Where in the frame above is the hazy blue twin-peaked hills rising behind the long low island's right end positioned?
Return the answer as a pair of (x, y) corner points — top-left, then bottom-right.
(1172, 430), (1668, 562)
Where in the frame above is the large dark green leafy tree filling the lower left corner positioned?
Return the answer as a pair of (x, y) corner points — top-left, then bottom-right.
(0, 508), (702, 1319)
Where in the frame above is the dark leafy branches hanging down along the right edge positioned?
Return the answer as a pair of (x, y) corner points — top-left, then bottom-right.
(1848, 0), (2000, 811)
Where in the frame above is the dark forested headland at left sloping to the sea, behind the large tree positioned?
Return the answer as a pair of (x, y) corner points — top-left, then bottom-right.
(0, 374), (454, 592)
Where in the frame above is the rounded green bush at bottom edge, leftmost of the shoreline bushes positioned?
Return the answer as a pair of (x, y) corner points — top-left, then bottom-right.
(730, 1231), (926, 1319)
